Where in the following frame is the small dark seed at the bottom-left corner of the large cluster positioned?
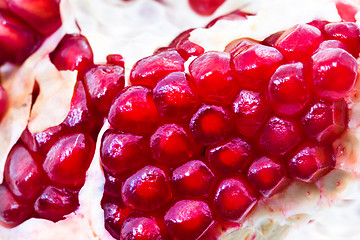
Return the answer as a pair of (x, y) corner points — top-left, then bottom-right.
(102, 202), (132, 239)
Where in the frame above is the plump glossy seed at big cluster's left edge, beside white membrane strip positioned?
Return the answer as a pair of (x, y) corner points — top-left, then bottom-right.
(100, 130), (150, 174)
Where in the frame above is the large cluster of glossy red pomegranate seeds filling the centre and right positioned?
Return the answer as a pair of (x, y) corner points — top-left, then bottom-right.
(97, 19), (360, 240)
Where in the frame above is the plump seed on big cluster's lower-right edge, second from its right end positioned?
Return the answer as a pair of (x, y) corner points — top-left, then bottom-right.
(248, 157), (286, 197)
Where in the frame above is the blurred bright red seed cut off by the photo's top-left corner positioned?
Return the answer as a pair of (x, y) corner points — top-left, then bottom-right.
(6, 0), (61, 35)
